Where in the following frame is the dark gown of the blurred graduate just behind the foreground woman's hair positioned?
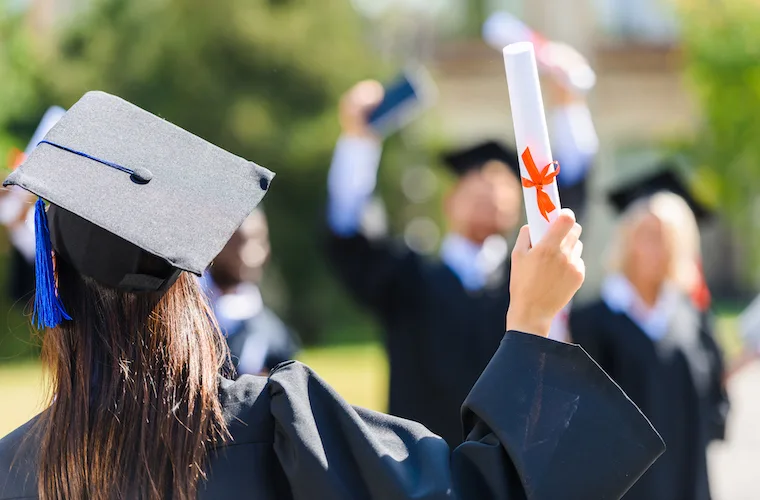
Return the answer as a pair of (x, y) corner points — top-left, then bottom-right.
(224, 306), (299, 371)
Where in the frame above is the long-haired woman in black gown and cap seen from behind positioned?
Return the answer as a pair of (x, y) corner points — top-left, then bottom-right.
(0, 92), (663, 500)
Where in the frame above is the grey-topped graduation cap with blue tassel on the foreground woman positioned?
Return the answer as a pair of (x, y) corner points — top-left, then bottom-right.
(3, 92), (274, 327)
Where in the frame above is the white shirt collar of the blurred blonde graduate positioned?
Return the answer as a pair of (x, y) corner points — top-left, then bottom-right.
(601, 274), (679, 341)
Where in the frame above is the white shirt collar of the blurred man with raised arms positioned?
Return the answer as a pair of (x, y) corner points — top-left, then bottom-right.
(440, 233), (509, 291)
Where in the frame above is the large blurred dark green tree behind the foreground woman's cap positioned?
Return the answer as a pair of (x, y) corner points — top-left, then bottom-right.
(0, 0), (410, 341)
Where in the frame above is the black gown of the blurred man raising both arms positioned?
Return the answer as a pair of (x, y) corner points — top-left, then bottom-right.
(328, 235), (509, 447)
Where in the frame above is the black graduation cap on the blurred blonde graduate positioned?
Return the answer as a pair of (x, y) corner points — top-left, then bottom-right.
(607, 167), (713, 222)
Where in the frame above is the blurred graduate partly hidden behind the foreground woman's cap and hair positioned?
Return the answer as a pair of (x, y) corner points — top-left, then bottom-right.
(202, 209), (300, 375)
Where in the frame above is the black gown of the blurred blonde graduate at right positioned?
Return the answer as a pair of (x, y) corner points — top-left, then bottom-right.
(570, 297), (728, 500)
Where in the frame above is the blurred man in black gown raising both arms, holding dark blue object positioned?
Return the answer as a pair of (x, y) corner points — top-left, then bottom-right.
(327, 61), (598, 446)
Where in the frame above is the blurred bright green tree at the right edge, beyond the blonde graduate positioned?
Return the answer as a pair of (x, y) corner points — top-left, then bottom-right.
(678, 0), (760, 279)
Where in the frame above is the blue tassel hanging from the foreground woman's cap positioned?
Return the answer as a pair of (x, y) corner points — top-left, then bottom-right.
(34, 198), (71, 329)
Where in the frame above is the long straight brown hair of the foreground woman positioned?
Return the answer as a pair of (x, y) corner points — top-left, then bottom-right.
(37, 259), (229, 500)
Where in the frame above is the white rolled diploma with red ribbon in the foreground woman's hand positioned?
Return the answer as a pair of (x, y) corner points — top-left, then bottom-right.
(504, 42), (561, 245)
